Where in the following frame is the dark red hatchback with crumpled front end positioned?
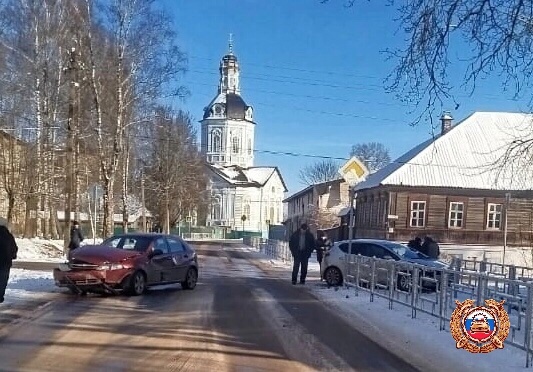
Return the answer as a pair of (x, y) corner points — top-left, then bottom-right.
(54, 233), (198, 296)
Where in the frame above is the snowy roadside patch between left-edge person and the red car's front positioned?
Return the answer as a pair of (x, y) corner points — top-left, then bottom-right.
(0, 269), (58, 308)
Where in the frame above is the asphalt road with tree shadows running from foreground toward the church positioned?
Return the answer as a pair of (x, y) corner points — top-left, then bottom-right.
(0, 246), (422, 372)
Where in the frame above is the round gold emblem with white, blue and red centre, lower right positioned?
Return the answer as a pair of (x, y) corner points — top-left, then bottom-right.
(450, 299), (511, 353)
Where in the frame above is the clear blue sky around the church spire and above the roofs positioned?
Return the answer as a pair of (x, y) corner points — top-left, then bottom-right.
(161, 0), (526, 194)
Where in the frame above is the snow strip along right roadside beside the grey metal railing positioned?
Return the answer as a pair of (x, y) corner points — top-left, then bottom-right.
(247, 248), (527, 371)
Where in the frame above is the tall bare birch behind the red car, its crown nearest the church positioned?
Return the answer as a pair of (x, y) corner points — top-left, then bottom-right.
(86, 0), (189, 236)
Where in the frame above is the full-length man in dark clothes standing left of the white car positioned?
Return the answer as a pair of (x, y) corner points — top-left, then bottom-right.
(289, 223), (315, 284)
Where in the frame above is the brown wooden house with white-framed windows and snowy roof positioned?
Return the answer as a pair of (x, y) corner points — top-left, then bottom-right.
(355, 112), (533, 246)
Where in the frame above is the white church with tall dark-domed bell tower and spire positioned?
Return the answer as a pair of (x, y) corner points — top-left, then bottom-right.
(200, 38), (287, 236)
